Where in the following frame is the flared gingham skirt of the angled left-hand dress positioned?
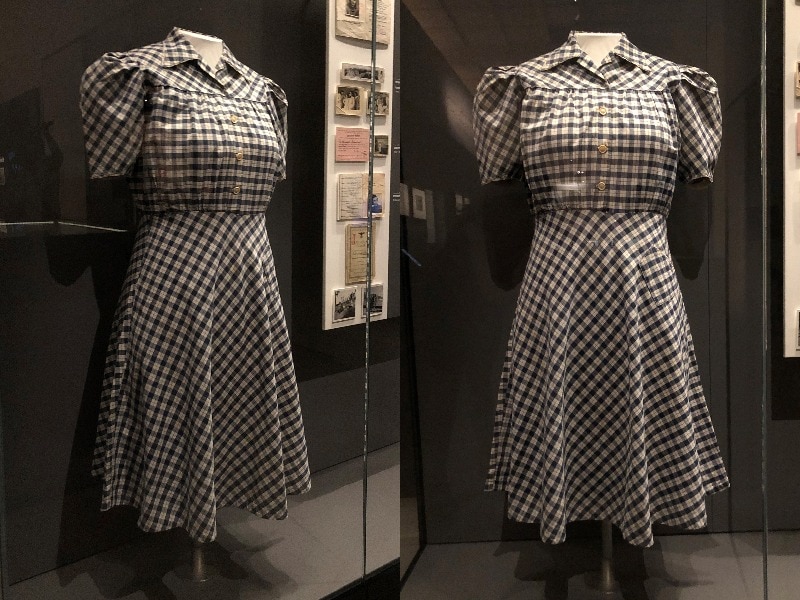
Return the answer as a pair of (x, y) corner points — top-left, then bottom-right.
(93, 211), (310, 542)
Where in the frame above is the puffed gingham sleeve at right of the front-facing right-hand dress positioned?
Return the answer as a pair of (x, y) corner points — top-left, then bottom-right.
(672, 67), (722, 182)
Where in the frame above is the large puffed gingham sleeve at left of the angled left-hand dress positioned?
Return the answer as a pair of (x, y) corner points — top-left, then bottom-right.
(80, 52), (145, 179)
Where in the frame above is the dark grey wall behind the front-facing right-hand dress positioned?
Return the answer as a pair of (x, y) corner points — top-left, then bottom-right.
(401, 0), (772, 543)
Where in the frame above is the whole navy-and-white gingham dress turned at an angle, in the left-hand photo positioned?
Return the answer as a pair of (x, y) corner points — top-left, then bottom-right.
(81, 29), (310, 542)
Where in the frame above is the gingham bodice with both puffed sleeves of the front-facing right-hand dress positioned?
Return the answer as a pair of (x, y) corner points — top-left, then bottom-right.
(474, 35), (722, 215)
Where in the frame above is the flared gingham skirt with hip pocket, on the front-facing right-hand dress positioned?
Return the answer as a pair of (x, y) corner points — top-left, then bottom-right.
(486, 210), (728, 546)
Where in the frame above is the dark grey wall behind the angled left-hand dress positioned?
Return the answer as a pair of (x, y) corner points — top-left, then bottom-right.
(0, 0), (399, 582)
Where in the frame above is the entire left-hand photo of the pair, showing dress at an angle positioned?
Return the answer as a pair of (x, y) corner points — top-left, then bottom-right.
(0, 0), (400, 600)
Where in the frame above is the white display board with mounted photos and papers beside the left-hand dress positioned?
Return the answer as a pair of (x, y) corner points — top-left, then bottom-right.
(322, 0), (396, 329)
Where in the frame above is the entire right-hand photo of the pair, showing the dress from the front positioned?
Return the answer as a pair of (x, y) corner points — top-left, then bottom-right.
(400, 0), (800, 600)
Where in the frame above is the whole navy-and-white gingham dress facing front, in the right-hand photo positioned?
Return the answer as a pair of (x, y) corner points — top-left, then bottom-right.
(474, 34), (728, 546)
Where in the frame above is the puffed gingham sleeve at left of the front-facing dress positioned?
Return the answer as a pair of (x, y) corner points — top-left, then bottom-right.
(472, 67), (524, 183)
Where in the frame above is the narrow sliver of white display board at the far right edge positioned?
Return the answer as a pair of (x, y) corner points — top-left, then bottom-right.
(783, 2), (800, 357)
